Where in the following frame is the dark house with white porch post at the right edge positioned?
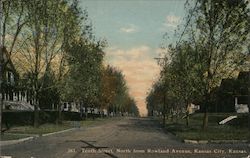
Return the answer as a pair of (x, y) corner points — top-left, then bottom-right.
(209, 71), (250, 113)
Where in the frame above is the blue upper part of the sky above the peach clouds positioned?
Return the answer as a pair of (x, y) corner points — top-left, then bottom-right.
(81, 0), (185, 48)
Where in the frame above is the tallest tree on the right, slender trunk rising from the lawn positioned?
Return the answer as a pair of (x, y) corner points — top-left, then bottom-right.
(184, 0), (250, 129)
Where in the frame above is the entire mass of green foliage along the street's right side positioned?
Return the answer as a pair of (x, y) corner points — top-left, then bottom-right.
(147, 0), (250, 127)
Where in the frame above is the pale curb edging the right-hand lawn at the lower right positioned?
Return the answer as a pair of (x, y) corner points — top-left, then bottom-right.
(183, 139), (249, 144)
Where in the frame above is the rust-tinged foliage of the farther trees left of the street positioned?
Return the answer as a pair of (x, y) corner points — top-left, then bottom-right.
(100, 65), (139, 116)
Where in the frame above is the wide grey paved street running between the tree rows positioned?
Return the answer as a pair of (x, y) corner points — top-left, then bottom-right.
(1, 118), (250, 158)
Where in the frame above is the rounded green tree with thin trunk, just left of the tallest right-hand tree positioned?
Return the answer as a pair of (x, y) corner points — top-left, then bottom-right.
(163, 42), (204, 125)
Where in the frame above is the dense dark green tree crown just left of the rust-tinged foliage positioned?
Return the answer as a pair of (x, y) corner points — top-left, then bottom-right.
(62, 37), (104, 118)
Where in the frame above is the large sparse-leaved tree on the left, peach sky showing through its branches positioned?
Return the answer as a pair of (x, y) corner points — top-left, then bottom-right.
(2, 0), (91, 127)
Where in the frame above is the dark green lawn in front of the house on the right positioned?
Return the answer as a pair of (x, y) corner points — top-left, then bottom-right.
(165, 113), (250, 141)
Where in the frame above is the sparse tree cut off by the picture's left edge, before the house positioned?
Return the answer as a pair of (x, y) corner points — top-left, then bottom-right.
(0, 0), (26, 134)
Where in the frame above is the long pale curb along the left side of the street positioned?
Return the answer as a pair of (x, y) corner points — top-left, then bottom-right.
(0, 128), (77, 147)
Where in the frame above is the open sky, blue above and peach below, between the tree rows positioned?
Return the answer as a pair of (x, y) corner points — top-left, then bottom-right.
(80, 0), (186, 116)
